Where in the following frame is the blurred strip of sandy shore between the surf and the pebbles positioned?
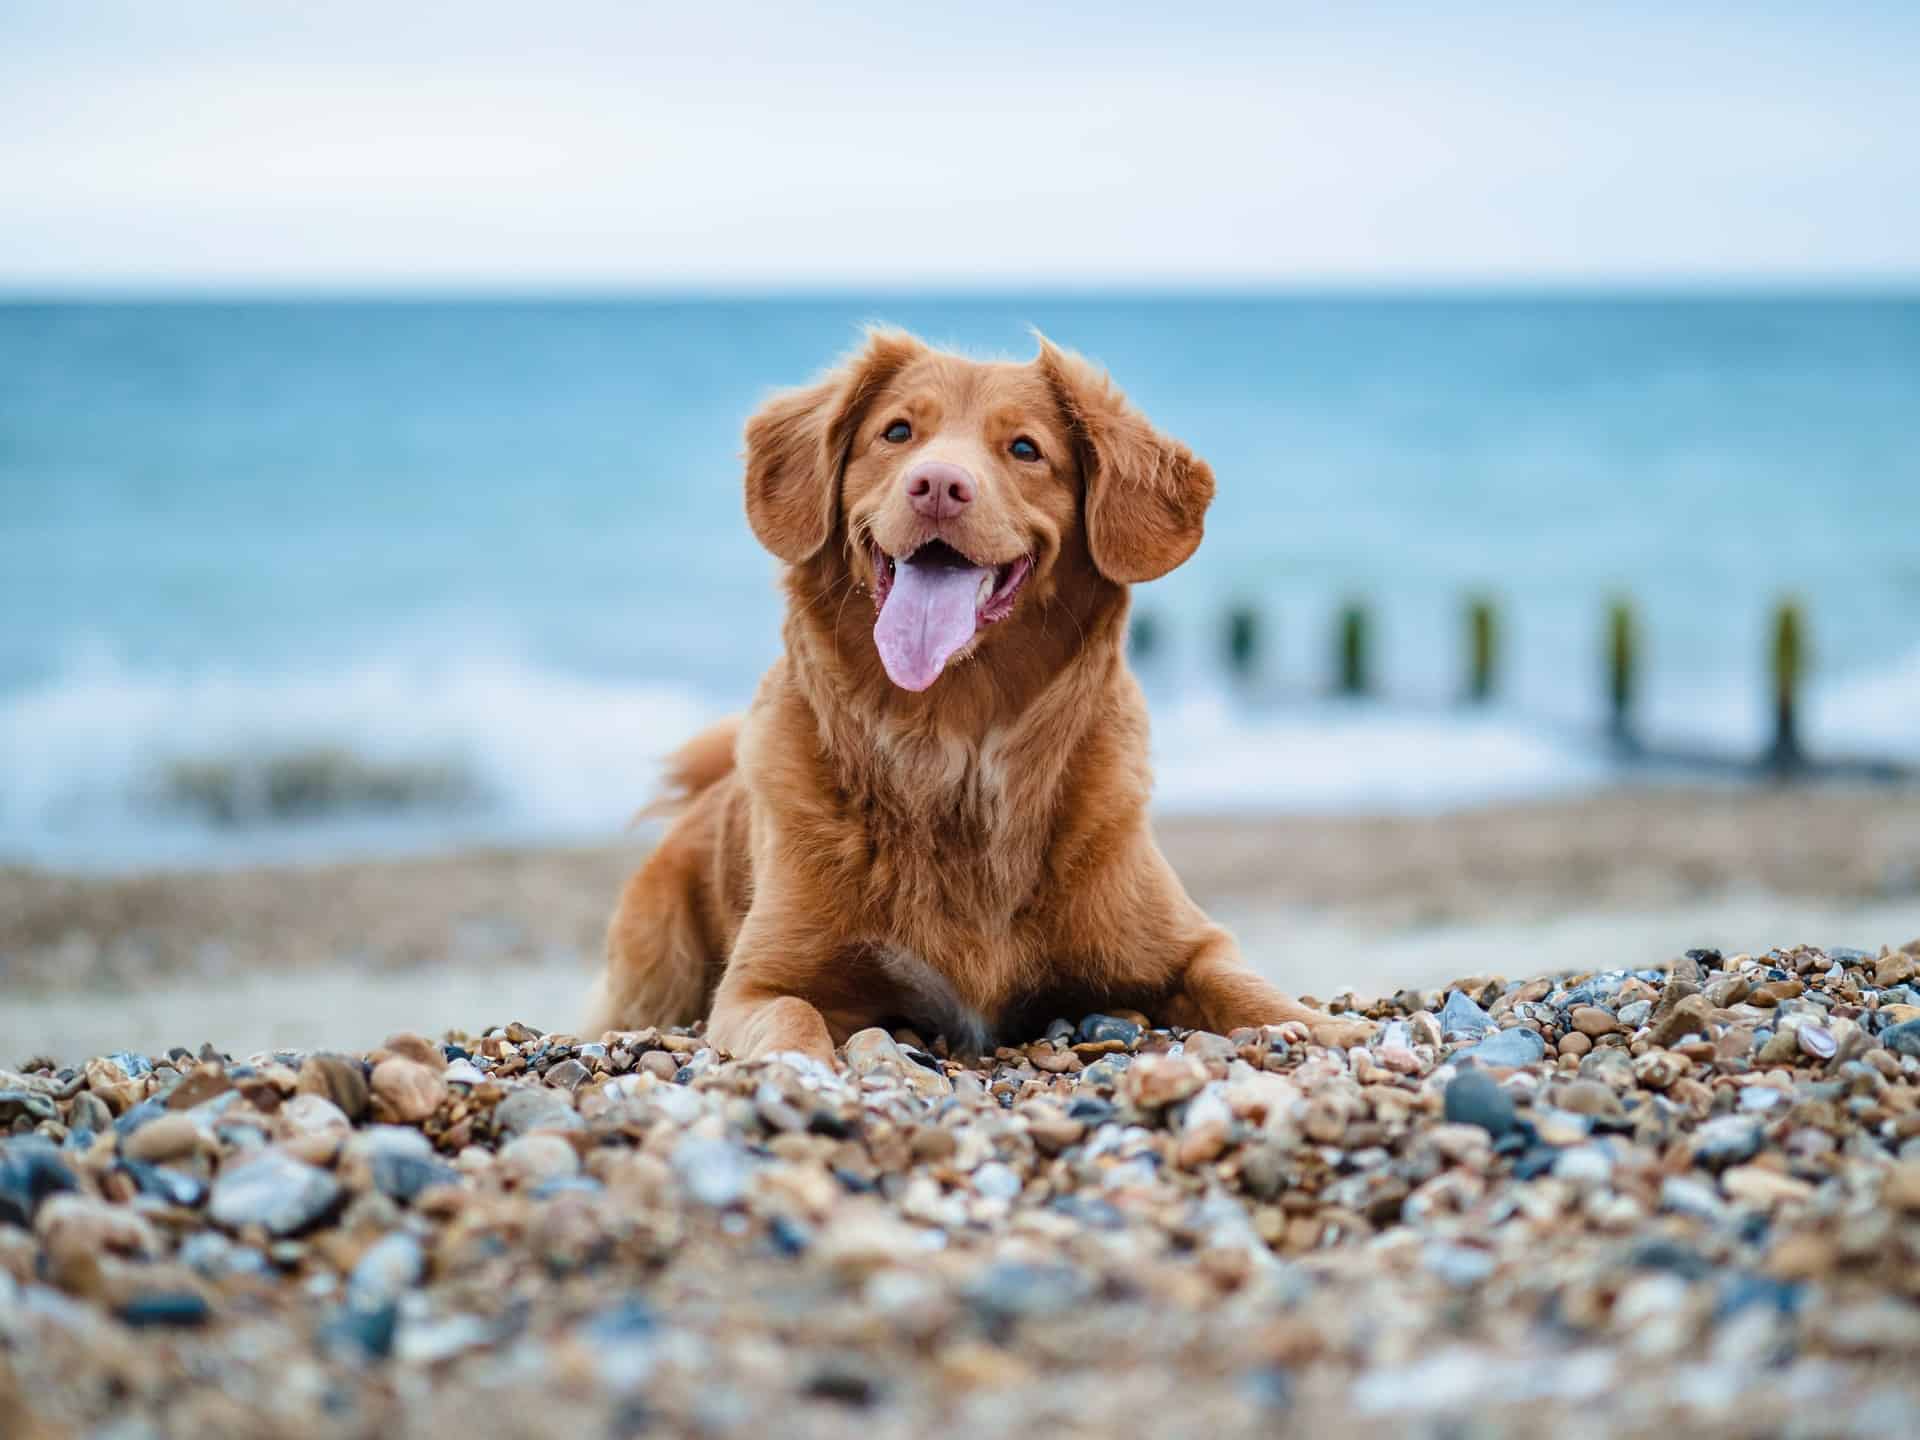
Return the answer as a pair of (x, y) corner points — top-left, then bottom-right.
(0, 787), (1920, 1064)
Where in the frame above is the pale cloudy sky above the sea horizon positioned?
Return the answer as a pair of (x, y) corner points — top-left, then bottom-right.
(0, 0), (1920, 292)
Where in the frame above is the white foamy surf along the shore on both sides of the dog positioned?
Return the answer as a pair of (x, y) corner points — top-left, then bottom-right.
(0, 653), (1920, 868)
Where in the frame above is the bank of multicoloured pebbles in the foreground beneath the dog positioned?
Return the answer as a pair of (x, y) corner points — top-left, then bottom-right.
(0, 941), (1920, 1440)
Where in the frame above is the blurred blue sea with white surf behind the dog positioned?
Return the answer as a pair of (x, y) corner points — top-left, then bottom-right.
(0, 294), (1920, 868)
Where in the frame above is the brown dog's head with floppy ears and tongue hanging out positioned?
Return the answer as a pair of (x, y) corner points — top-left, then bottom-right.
(747, 332), (1213, 691)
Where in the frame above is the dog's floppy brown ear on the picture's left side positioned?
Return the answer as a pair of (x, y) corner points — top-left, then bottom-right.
(747, 330), (925, 564)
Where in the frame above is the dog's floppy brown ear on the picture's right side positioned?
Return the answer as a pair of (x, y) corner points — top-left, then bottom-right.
(1037, 336), (1213, 586)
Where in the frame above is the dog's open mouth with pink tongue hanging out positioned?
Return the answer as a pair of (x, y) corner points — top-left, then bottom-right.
(868, 540), (1033, 691)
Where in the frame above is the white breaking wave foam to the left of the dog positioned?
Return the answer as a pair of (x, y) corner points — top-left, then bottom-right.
(0, 655), (724, 864)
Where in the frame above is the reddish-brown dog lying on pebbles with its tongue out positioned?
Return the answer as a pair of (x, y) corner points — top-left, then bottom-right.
(588, 332), (1369, 1060)
